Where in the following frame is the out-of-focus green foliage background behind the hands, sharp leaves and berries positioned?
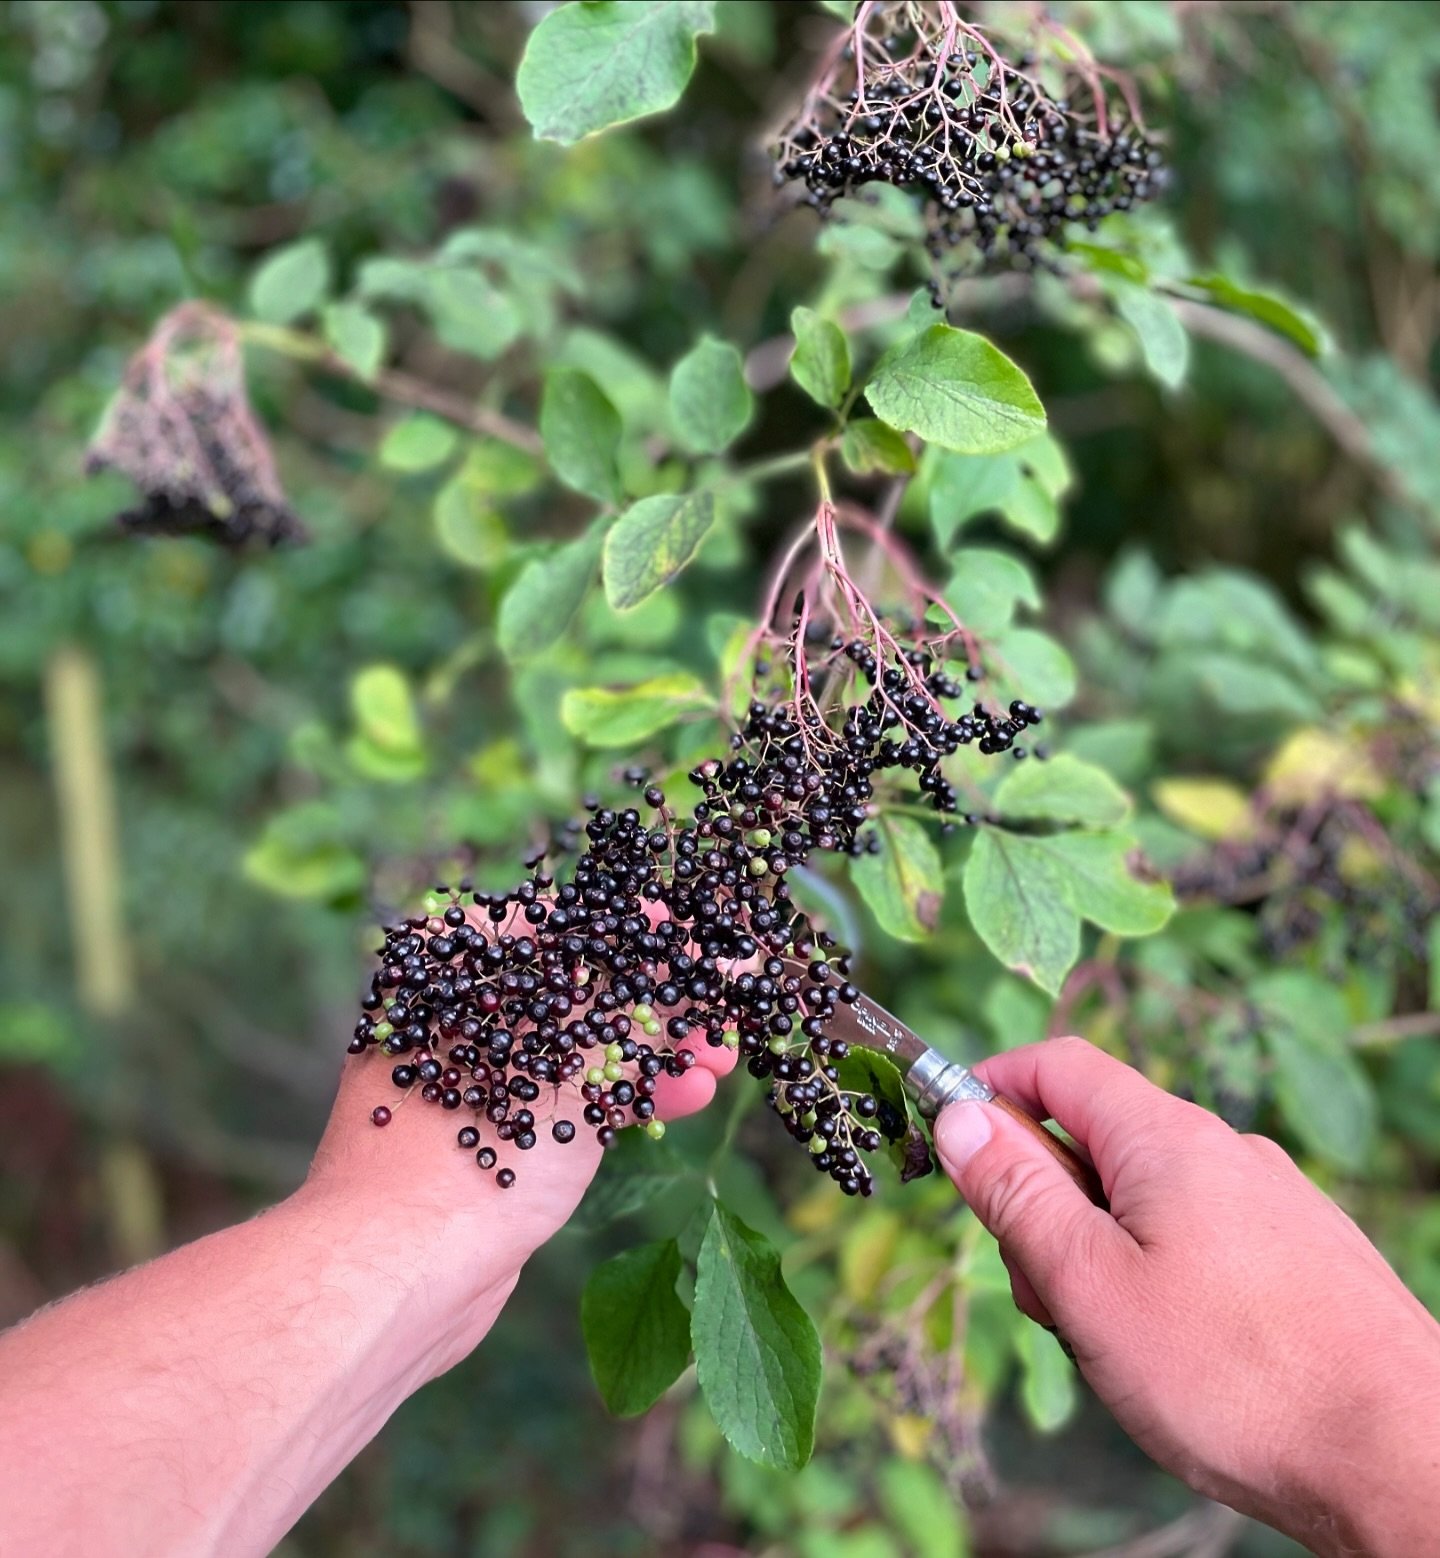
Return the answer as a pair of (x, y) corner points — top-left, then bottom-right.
(0, 0), (1440, 1558)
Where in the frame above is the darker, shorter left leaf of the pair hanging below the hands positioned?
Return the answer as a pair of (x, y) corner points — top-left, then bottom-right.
(580, 1239), (690, 1418)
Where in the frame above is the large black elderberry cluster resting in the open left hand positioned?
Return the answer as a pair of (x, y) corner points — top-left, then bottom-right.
(351, 640), (1041, 1195)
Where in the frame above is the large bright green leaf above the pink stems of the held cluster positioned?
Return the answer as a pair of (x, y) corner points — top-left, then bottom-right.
(865, 324), (1046, 455)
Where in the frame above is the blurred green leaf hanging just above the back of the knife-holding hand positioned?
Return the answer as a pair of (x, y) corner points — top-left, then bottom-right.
(1250, 969), (1378, 1173)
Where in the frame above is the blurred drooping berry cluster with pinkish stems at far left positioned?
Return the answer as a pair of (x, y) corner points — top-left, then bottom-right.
(87, 304), (304, 547)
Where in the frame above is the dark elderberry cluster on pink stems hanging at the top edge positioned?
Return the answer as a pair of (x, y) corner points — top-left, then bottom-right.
(776, 3), (1164, 273)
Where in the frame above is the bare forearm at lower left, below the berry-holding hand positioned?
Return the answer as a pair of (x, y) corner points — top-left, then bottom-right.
(0, 1184), (528, 1558)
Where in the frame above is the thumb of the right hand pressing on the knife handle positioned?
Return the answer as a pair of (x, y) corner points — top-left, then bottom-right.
(935, 1102), (1127, 1309)
